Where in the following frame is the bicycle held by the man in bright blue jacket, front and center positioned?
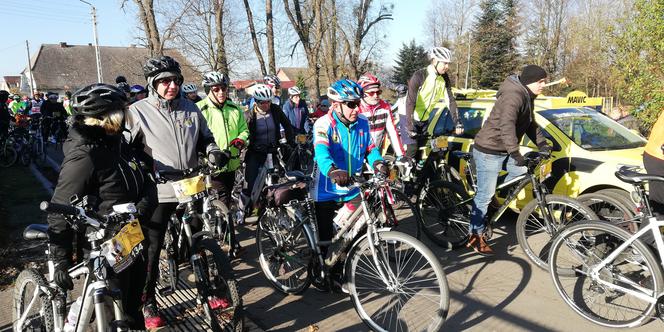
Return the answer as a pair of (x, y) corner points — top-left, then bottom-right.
(256, 176), (449, 331)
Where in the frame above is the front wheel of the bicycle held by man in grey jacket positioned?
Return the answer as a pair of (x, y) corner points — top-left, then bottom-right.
(192, 238), (244, 332)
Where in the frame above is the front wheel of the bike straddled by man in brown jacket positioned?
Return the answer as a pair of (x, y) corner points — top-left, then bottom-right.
(516, 195), (597, 270)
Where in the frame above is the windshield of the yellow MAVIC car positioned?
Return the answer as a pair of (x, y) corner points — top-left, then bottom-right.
(539, 107), (646, 151)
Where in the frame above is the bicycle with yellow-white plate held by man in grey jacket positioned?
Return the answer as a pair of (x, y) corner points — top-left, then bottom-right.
(156, 164), (244, 331)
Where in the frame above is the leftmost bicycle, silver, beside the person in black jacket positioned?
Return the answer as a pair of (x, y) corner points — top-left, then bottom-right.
(13, 197), (143, 331)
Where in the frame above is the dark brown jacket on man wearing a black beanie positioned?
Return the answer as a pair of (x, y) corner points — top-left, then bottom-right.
(474, 75), (547, 154)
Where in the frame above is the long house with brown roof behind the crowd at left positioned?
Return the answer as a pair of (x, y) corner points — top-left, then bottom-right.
(21, 42), (201, 94)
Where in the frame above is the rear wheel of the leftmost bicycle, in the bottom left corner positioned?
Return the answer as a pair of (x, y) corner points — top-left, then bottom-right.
(12, 269), (54, 332)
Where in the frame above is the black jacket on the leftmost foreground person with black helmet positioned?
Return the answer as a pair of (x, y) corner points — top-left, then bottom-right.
(48, 122), (157, 262)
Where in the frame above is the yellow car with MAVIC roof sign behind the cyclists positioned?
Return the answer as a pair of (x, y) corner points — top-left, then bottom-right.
(438, 90), (646, 208)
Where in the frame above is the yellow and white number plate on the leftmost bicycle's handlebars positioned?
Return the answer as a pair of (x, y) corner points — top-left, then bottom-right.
(101, 219), (145, 273)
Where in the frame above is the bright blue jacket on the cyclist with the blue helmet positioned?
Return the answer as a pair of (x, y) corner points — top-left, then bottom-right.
(311, 111), (382, 202)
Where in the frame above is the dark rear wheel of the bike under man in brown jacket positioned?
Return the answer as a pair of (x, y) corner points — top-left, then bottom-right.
(417, 180), (471, 249)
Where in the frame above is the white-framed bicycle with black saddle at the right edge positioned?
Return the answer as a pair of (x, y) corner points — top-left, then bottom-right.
(549, 167), (664, 327)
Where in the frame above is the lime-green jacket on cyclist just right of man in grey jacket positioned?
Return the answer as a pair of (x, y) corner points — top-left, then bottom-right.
(196, 98), (249, 172)
